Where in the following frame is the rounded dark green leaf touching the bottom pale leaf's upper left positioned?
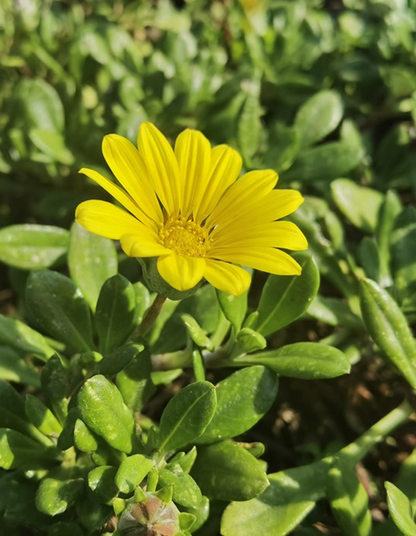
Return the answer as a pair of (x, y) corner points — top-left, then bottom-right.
(191, 441), (269, 501)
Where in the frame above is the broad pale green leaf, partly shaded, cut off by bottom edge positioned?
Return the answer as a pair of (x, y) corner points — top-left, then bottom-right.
(221, 454), (329, 536)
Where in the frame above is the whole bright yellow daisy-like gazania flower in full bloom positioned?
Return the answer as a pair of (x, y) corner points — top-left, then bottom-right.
(76, 123), (307, 295)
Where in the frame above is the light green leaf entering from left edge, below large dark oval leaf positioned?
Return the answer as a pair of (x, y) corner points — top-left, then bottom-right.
(0, 315), (55, 361)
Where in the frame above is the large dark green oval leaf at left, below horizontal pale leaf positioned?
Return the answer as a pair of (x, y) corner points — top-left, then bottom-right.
(26, 270), (94, 352)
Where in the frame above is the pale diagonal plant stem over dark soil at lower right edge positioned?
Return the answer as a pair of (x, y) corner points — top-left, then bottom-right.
(338, 400), (415, 465)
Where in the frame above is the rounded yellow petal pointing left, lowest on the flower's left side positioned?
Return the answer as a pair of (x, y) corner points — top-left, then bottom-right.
(75, 200), (150, 240)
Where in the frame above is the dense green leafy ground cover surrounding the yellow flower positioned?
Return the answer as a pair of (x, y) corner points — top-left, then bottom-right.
(0, 0), (416, 536)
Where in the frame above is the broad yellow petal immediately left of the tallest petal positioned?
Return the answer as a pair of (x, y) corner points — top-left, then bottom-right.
(102, 134), (163, 223)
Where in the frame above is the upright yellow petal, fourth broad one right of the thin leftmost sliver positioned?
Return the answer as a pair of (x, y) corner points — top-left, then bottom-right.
(194, 145), (243, 221)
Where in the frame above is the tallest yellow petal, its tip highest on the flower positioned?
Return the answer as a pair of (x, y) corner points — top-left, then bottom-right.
(137, 122), (181, 214)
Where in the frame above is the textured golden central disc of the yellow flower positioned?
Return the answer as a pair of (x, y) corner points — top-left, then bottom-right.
(159, 216), (211, 257)
